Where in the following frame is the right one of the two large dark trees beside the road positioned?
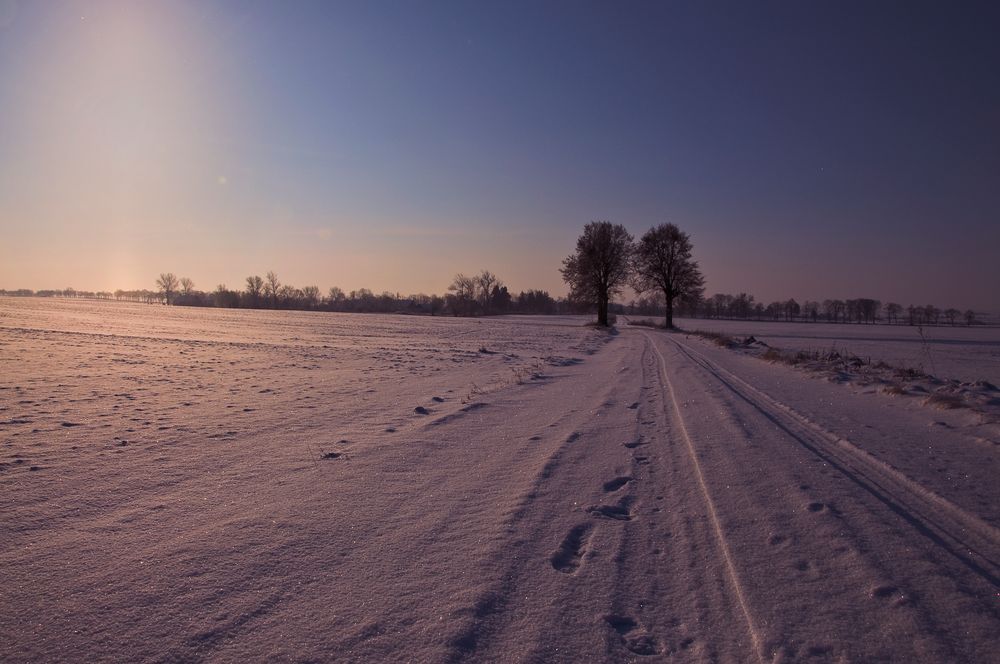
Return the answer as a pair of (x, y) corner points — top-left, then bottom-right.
(632, 224), (704, 328)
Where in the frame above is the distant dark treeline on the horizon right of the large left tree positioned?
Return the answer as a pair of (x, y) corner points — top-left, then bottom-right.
(618, 293), (984, 325)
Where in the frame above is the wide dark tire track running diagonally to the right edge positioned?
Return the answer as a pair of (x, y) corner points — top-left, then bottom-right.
(669, 338), (1000, 586)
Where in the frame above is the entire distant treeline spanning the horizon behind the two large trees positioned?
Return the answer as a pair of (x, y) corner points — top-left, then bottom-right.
(0, 282), (985, 325)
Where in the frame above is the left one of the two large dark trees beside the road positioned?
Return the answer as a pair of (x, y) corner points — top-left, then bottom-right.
(559, 221), (632, 326)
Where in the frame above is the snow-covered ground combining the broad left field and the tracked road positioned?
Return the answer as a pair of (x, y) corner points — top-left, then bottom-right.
(0, 299), (1000, 662)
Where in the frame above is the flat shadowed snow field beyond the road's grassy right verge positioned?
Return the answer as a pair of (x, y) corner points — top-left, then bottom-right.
(664, 318), (1000, 385)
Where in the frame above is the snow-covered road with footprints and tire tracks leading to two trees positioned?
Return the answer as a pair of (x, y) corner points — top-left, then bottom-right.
(432, 331), (1000, 662)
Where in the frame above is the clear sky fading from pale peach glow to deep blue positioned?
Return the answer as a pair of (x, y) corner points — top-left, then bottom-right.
(0, 0), (1000, 311)
